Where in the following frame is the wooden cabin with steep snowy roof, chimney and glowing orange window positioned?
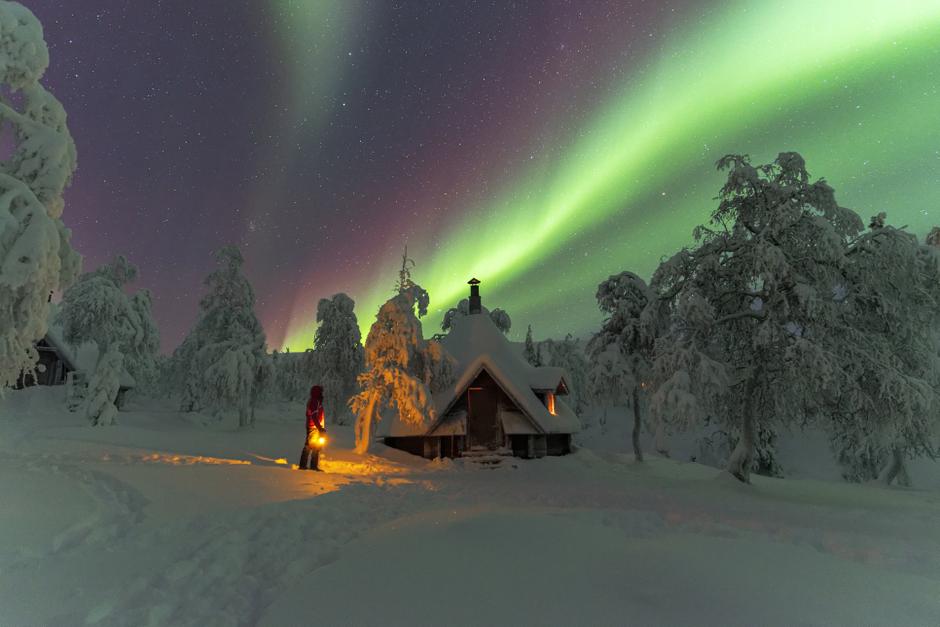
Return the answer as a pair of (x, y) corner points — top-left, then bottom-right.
(379, 279), (580, 458)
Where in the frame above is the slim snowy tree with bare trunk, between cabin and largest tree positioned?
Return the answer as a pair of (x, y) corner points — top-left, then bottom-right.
(587, 272), (659, 461)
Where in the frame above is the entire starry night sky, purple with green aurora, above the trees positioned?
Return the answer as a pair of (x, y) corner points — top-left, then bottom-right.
(24, 0), (940, 351)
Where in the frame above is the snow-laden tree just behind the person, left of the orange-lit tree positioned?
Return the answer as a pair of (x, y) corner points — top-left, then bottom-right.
(314, 293), (363, 424)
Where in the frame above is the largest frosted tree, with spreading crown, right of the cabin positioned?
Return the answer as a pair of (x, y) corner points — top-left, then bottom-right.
(652, 153), (862, 481)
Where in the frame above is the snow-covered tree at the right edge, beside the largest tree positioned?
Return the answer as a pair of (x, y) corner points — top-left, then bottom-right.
(830, 214), (940, 484)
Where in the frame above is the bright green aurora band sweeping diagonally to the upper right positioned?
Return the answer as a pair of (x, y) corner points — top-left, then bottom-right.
(284, 0), (940, 347)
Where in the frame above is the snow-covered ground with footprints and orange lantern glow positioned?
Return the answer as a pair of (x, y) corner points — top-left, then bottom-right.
(0, 388), (940, 627)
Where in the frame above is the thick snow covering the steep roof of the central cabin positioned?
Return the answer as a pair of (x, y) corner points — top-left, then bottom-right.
(434, 314), (580, 433)
